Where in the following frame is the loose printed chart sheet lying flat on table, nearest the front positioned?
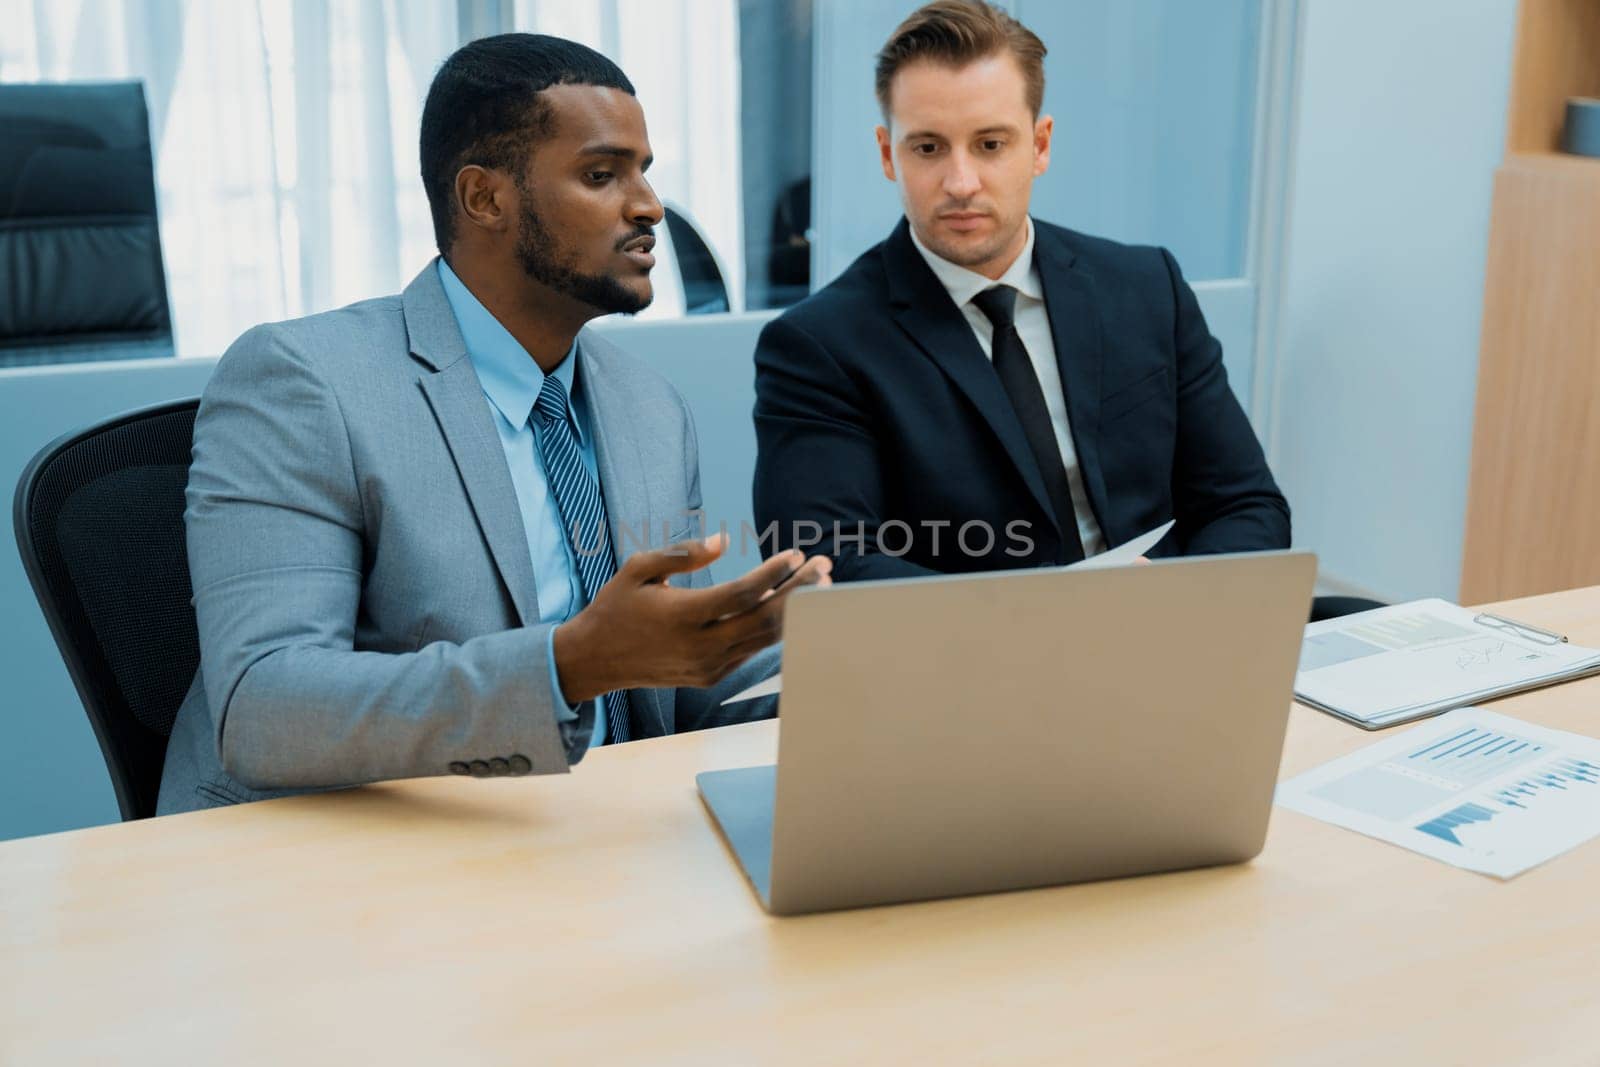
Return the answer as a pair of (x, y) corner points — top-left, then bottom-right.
(1277, 707), (1600, 878)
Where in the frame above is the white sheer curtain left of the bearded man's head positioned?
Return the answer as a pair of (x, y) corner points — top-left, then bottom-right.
(0, 0), (456, 355)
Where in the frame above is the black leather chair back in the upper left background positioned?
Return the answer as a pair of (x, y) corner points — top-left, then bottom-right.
(0, 82), (173, 366)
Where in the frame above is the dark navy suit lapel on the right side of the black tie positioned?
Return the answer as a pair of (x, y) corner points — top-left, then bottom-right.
(1034, 222), (1106, 528)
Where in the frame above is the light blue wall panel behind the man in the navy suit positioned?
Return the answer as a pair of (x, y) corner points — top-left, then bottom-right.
(813, 0), (1261, 283)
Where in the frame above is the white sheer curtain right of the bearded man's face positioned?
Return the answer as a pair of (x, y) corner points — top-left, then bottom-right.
(514, 0), (744, 318)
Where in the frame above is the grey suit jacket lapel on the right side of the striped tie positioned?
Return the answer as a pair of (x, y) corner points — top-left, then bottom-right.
(574, 331), (674, 734)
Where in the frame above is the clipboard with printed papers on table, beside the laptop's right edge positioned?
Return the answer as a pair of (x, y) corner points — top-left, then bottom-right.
(1294, 600), (1600, 729)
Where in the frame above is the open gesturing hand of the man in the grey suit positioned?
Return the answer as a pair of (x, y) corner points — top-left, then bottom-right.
(555, 534), (834, 704)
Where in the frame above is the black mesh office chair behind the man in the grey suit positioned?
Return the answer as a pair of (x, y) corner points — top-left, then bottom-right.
(13, 400), (200, 819)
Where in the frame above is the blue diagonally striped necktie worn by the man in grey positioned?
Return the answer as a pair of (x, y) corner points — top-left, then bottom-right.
(533, 374), (632, 742)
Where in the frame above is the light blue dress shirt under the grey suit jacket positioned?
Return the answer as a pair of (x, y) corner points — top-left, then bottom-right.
(438, 259), (606, 745)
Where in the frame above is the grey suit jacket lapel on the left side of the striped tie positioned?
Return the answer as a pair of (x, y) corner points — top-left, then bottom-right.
(402, 264), (539, 625)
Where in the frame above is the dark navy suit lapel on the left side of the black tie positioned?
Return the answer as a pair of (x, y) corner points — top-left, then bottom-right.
(883, 219), (1059, 543)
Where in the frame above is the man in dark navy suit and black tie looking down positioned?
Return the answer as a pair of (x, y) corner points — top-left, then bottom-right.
(755, 0), (1290, 581)
